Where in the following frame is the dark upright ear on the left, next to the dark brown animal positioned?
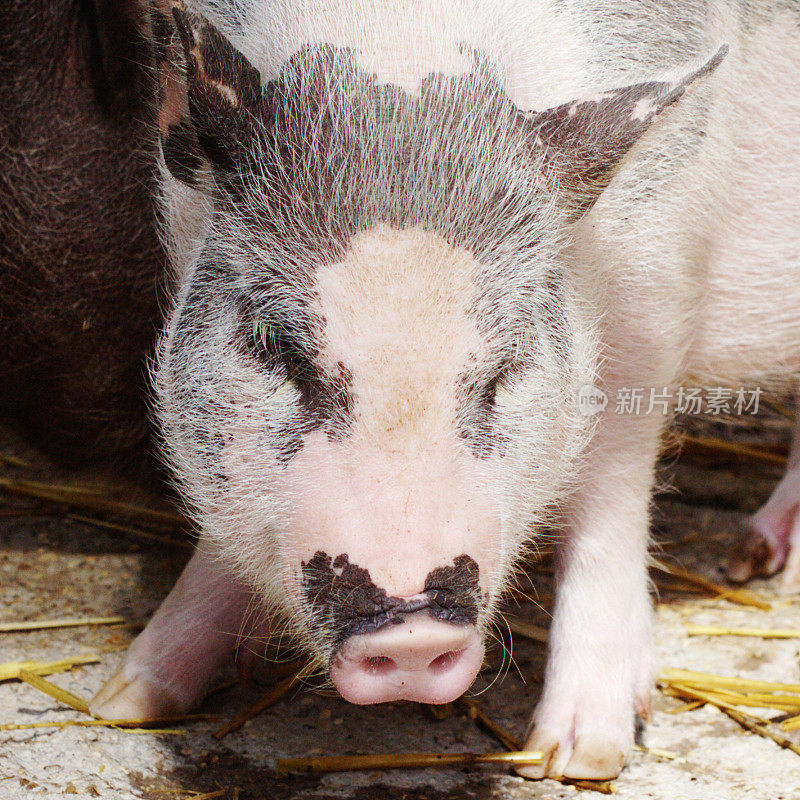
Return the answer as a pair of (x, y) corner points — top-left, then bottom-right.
(150, 0), (262, 188)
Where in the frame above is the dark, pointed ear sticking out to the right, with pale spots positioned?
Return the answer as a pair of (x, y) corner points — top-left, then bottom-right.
(526, 45), (728, 219)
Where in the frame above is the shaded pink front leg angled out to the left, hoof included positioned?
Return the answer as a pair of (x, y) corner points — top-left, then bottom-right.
(90, 541), (262, 719)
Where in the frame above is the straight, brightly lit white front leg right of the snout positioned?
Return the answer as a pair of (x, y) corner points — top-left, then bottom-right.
(519, 410), (665, 779)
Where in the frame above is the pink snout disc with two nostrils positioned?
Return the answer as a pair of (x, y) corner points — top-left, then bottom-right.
(330, 611), (483, 705)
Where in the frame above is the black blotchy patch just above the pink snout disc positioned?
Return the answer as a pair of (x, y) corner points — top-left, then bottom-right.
(301, 551), (480, 649)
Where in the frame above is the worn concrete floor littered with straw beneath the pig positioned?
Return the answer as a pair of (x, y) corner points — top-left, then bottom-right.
(0, 422), (800, 800)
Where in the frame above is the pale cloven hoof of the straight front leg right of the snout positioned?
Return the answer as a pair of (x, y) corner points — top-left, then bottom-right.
(516, 730), (625, 780)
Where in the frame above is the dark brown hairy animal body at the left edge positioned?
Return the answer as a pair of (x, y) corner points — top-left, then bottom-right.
(0, 0), (166, 490)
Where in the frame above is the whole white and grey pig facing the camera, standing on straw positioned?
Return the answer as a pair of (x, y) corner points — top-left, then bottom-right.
(6, 0), (800, 778)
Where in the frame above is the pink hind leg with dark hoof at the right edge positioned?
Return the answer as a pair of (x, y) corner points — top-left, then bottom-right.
(726, 400), (800, 594)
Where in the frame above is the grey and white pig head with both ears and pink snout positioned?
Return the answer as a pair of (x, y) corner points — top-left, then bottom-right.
(126, 8), (721, 703)
